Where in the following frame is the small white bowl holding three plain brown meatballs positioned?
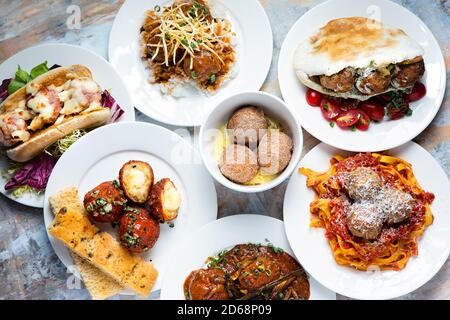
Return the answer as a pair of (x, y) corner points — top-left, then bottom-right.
(199, 91), (303, 193)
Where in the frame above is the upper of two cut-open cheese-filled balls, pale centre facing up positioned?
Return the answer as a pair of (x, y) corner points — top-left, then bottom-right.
(119, 160), (154, 204)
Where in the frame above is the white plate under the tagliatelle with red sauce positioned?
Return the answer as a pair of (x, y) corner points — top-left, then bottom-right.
(283, 142), (450, 299)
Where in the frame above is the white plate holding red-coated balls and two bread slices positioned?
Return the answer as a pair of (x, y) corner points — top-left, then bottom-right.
(44, 122), (217, 291)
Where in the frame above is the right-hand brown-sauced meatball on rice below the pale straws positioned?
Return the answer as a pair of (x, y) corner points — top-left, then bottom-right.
(183, 50), (222, 85)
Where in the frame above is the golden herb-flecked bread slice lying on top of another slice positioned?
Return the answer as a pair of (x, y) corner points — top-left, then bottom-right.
(49, 198), (158, 297)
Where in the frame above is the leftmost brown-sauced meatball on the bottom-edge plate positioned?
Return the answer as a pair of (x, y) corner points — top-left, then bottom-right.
(184, 269), (230, 300)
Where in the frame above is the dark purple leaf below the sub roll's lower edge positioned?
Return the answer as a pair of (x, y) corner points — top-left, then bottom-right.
(5, 153), (56, 190)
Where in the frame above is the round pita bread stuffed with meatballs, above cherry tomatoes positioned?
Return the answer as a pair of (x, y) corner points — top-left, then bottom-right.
(294, 17), (425, 100)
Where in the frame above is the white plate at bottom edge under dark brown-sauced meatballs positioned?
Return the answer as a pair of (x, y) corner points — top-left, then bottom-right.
(161, 214), (336, 300)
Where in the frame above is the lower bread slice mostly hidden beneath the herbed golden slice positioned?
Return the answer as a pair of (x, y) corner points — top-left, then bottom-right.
(49, 187), (124, 300)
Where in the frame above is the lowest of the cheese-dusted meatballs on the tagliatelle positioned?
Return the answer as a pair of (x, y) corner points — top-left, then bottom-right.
(347, 201), (384, 240)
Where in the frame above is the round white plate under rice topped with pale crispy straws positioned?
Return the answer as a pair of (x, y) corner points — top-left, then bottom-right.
(109, 0), (273, 126)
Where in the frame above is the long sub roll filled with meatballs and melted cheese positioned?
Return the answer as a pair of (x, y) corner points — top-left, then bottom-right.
(0, 65), (110, 162)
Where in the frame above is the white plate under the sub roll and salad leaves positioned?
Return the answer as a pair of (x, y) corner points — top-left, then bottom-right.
(0, 44), (134, 208)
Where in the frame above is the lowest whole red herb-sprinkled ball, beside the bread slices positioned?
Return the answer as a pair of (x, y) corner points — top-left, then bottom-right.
(119, 207), (160, 253)
